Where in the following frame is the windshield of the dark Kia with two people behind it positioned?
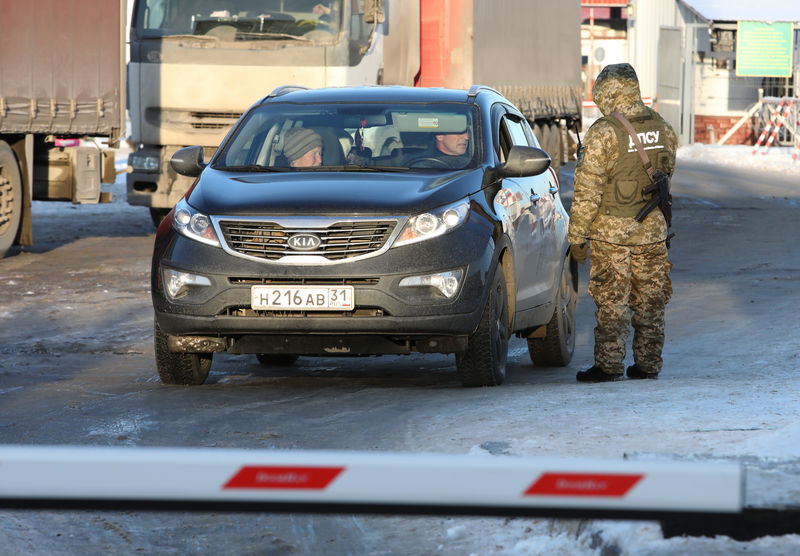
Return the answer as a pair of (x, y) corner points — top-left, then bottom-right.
(213, 103), (480, 171)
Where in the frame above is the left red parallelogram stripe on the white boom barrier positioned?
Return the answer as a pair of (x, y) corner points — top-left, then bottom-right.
(222, 465), (344, 490)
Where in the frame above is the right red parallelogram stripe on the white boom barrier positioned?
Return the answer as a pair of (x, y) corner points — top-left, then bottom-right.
(525, 473), (644, 498)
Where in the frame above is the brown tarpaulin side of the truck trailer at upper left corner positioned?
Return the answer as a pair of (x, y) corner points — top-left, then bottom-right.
(0, 0), (124, 135)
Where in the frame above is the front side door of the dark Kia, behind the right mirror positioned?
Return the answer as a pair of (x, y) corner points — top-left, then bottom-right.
(498, 108), (547, 310)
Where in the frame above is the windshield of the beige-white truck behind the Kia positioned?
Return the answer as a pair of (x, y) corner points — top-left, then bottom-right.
(133, 0), (342, 41)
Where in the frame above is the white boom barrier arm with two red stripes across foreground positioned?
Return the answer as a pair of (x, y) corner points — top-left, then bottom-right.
(0, 446), (743, 516)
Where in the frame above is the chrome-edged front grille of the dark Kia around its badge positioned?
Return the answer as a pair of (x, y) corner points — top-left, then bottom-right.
(219, 219), (397, 261)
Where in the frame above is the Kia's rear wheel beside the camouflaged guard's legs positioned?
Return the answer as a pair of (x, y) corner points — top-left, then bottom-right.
(528, 257), (578, 367)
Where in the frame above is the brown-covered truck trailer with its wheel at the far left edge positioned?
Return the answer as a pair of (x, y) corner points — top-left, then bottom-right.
(0, 0), (126, 257)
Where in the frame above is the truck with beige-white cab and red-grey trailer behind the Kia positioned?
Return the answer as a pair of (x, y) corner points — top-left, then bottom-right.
(127, 0), (582, 223)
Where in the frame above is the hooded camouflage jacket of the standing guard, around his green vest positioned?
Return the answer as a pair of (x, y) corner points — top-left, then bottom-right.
(568, 64), (678, 245)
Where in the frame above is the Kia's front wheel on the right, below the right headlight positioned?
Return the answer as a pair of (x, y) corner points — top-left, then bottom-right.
(456, 265), (509, 386)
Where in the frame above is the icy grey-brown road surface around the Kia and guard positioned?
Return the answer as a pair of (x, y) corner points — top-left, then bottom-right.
(0, 146), (800, 556)
